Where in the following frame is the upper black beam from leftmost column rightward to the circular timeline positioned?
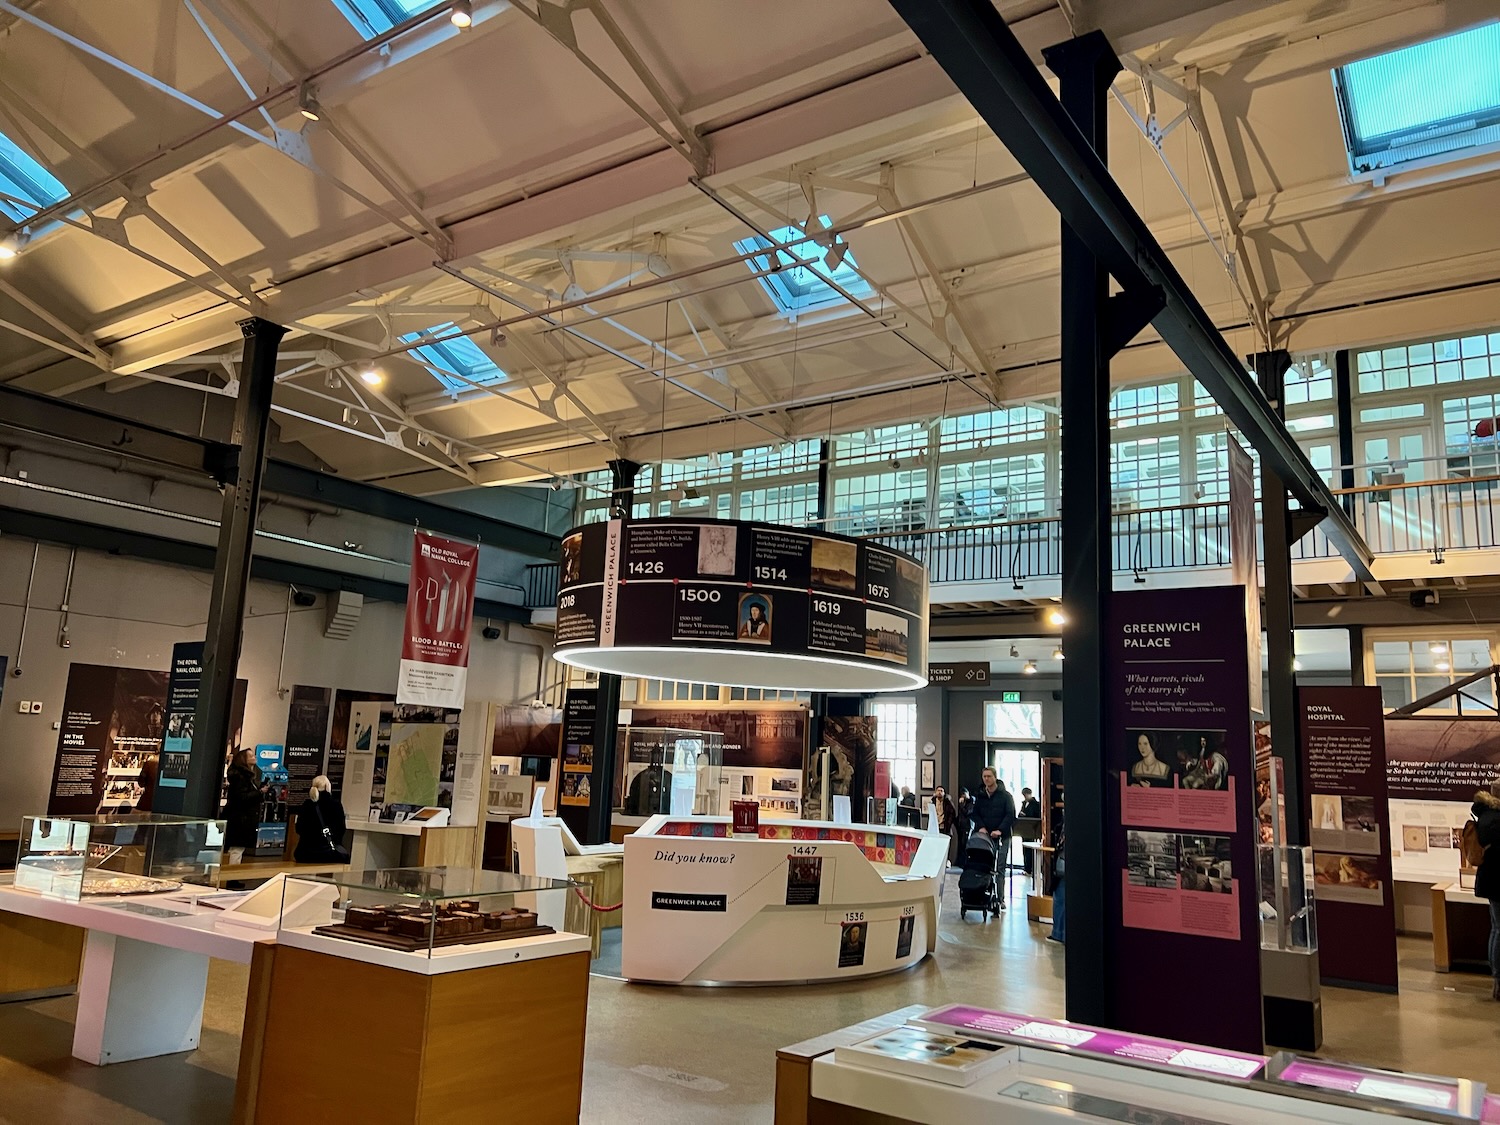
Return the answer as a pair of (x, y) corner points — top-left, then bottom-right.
(264, 461), (563, 563)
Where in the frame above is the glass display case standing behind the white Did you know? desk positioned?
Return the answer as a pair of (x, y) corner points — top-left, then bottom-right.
(614, 726), (723, 816)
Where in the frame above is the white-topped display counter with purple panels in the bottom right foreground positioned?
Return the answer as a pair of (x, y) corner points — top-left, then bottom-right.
(776, 1005), (1500, 1125)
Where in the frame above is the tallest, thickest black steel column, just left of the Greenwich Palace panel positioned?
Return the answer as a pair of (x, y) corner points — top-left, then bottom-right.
(1043, 32), (1121, 1026)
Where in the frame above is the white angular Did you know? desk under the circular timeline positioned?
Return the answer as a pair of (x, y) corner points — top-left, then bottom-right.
(621, 816), (948, 984)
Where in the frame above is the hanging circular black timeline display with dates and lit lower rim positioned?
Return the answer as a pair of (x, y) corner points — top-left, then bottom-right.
(555, 518), (927, 692)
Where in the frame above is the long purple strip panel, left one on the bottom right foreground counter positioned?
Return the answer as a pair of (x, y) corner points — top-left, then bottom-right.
(912, 1004), (1269, 1080)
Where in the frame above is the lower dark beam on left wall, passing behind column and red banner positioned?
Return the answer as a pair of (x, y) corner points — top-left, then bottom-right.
(0, 504), (531, 624)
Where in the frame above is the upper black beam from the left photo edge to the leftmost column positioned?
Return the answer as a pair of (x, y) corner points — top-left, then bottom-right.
(0, 387), (234, 482)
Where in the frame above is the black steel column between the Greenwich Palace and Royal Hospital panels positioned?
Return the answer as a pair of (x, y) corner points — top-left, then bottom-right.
(1250, 350), (1305, 845)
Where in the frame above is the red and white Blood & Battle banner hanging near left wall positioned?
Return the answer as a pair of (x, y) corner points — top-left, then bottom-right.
(396, 531), (479, 708)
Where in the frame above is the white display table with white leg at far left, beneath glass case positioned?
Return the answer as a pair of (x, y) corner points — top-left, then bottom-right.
(0, 884), (273, 1067)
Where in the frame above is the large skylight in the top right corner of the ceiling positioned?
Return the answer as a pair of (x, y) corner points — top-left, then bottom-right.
(1334, 24), (1500, 179)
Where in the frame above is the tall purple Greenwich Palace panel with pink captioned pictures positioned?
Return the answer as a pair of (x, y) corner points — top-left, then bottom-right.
(1104, 587), (1263, 1052)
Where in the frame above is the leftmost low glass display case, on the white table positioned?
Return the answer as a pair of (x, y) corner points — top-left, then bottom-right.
(14, 813), (224, 902)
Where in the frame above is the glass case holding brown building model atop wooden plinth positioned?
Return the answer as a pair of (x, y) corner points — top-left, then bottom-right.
(279, 867), (588, 957)
